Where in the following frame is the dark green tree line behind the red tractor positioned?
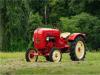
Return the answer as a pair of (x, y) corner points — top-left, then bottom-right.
(0, 0), (100, 51)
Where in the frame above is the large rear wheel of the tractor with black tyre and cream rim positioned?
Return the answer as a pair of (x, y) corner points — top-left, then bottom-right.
(70, 37), (86, 61)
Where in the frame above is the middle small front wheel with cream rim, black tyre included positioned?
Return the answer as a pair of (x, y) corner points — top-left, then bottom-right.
(49, 48), (62, 62)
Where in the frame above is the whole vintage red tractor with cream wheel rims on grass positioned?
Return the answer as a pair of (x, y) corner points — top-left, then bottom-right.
(26, 28), (86, 62)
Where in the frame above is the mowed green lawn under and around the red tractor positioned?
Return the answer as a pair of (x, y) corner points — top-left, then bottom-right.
(0, 52), (100, 75)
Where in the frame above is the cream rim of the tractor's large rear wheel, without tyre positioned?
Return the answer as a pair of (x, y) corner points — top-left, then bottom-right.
(75, 41), (85, 59)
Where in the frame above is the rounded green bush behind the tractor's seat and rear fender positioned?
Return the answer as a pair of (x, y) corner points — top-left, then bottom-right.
(60, 13), (100, 49)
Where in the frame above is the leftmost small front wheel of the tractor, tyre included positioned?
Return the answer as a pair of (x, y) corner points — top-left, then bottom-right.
(25, 48), (38, 62)
